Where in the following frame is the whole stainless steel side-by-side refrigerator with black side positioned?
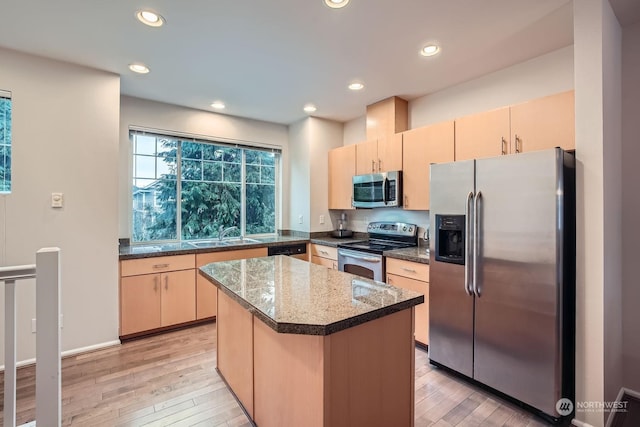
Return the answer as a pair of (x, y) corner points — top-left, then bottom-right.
(429, 148), (575, 418)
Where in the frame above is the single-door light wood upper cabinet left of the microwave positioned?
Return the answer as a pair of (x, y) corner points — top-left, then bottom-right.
(329, 144), (356, 209)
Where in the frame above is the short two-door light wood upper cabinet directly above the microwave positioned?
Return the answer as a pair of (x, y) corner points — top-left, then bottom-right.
(356, 134), (402, 175)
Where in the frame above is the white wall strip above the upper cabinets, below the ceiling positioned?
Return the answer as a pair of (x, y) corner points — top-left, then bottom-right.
(344, 46), (573, 145)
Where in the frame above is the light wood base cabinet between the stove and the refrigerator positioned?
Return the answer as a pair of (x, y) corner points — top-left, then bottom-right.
(386, 258), (429, 345)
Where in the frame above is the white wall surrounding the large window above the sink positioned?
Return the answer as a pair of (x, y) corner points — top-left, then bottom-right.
(118, 96), (289, 238)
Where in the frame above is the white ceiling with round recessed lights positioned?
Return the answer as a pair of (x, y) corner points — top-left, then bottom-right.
(0, 0), (580, 124)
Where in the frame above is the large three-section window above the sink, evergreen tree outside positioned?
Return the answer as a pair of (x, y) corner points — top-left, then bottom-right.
(131, 131), (280, 242)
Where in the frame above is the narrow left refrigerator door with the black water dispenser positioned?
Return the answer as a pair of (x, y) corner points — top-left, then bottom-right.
(429, 160), (474, 377)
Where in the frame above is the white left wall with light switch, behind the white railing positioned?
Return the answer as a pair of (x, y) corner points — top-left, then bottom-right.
(0, 49), (120, 361)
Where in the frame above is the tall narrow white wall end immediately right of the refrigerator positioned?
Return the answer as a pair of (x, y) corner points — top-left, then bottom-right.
(574, 0), (621, 426)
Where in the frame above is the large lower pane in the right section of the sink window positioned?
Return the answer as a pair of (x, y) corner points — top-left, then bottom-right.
(246, 184), (276, 234)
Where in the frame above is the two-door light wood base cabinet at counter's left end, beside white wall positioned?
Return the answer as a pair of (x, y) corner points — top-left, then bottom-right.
(120, 255), (196, 335)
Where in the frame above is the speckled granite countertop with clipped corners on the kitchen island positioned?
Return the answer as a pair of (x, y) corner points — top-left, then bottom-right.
(200, 256), (424, 335)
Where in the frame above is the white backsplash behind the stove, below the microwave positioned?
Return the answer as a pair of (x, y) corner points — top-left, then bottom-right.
(330, 208), (429, 238)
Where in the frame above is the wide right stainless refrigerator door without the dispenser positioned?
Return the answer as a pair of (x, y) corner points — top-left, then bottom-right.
(474, 150), (563, 416)
